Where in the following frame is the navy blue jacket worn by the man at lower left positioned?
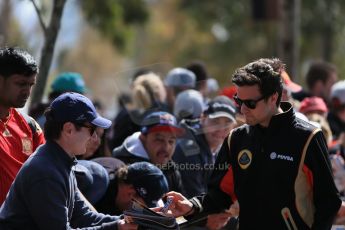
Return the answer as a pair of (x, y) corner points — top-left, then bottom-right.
(0, 141), (118, 230)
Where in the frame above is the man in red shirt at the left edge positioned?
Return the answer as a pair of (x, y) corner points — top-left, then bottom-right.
(0, 48), (45, 205)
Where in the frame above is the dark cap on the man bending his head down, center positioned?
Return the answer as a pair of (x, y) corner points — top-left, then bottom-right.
(127, 162), (169, 208)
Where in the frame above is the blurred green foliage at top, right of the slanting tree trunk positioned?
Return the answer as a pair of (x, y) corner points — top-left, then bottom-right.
(80, 0), (148, 51)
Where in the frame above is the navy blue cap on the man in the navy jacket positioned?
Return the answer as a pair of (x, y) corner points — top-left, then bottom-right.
(50, 93), (111, 129)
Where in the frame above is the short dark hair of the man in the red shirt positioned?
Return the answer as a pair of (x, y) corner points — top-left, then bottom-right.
(0, 47), (38, 78)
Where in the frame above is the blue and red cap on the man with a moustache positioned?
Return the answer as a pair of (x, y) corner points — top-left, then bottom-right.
(141, 111), (184, 136)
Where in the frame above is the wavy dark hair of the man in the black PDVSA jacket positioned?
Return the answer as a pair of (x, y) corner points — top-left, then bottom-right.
(232, 60), (283, 106)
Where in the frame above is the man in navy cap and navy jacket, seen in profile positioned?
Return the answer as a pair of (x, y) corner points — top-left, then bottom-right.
(0, 93), (137, 229)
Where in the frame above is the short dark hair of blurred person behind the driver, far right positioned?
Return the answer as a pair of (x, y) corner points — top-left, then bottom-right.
(305, 61), (338, 90)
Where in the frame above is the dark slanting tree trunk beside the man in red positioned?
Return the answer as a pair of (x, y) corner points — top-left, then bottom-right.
(31, 0), (66, 105)
